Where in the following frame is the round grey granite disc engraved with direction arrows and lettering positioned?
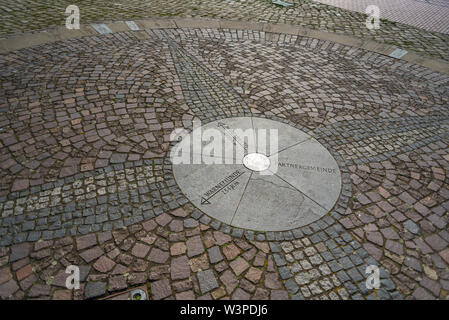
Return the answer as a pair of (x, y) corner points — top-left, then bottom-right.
(171, 117), (341, 231)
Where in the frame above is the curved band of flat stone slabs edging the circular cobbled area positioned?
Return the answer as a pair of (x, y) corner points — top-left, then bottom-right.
(0, 19), (449, 74)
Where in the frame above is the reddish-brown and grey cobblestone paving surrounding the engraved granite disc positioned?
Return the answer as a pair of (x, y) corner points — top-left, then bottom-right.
(0, 25), (449, 299)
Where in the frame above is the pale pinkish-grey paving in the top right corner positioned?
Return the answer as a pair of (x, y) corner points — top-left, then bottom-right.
(316, 0), (449, 34)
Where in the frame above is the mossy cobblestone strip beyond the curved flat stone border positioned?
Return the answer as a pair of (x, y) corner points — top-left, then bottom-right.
(0, 0), (449, 60)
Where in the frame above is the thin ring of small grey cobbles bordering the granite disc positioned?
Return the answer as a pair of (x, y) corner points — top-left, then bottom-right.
(164, 113), (352, 241)
